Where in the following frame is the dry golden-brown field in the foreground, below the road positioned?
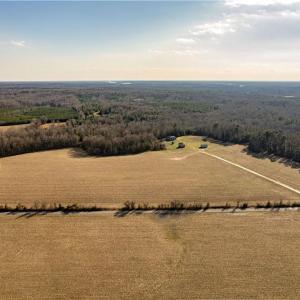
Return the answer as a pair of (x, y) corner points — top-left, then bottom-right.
(0, 212), (300, 299)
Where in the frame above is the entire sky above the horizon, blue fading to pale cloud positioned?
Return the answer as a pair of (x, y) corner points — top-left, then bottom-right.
(0, 0), (300, 81)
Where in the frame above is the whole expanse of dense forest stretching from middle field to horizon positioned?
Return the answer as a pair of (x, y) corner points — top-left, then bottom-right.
(0, 82), (300, 162)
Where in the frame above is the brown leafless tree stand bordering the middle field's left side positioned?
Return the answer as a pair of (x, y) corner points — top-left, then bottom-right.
(0, 123), (163, 157)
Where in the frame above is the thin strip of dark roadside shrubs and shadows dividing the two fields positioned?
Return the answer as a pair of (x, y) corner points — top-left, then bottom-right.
(0, 201), (300, 219)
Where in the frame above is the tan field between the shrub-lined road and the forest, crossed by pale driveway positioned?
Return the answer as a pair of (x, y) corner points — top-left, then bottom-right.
(0, 137), (300, 206)
